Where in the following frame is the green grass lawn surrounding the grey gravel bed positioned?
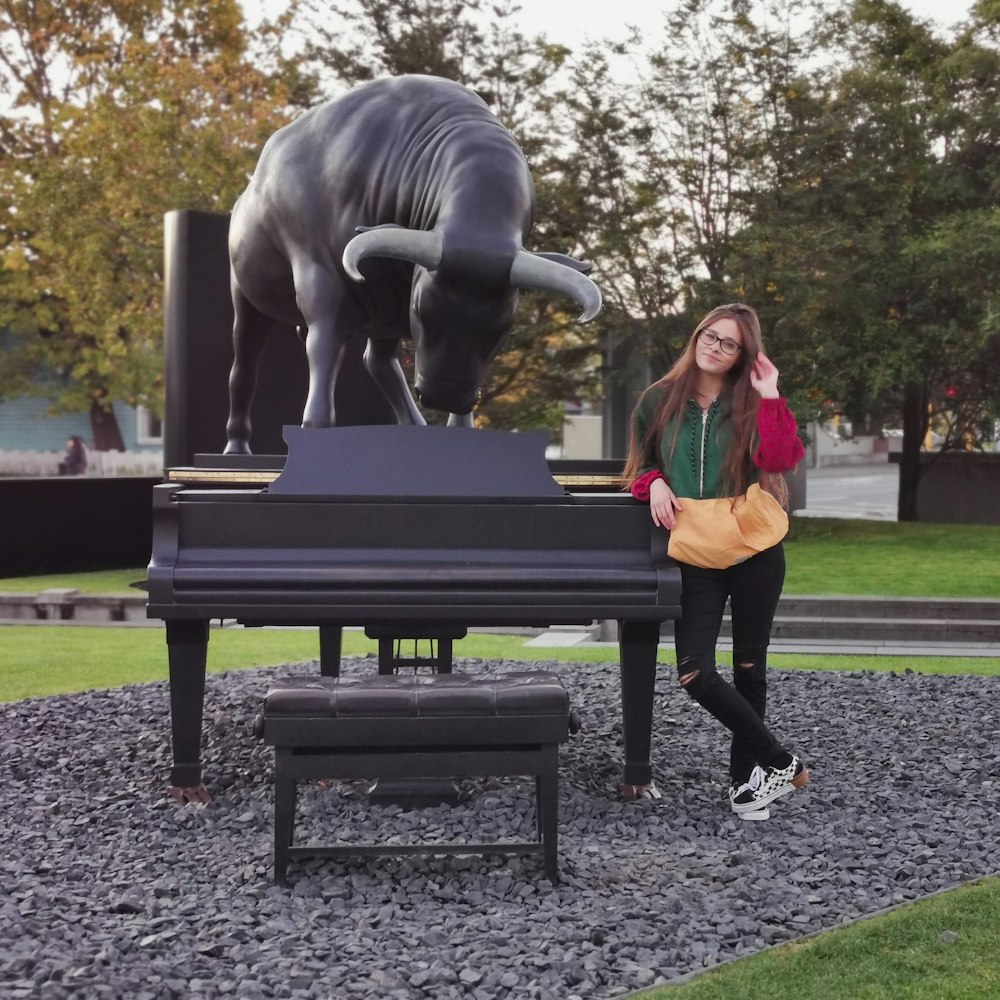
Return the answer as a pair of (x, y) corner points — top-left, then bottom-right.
(0, 518), (1000, 1000)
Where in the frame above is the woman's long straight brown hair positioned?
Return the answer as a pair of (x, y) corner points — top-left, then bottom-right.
(622, 302), (788, 503)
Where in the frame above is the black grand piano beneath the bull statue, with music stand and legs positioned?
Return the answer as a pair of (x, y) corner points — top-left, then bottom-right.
(147, 426), (680, 794)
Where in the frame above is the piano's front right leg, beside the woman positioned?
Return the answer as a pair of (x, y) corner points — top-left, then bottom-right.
(618, 621), (660, 785)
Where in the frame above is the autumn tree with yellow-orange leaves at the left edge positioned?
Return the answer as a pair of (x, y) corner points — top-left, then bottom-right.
(0, 0), (308, 449)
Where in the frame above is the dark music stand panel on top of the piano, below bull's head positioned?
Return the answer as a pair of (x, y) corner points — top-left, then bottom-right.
(267, 425), (564, 499)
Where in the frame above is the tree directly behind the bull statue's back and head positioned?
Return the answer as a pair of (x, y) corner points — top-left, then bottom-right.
(292, 0), (599, 433)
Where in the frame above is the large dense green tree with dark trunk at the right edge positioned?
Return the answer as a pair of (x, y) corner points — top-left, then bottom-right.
(740, 0), (1000, 520)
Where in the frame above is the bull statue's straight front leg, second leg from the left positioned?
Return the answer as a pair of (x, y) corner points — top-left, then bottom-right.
(292, 260), (347, 427)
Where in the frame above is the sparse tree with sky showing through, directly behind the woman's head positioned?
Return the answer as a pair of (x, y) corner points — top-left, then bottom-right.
(544, 0), (824, 452)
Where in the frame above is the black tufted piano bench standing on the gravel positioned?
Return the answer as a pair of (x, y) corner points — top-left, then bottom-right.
(254, 671), (579, 885)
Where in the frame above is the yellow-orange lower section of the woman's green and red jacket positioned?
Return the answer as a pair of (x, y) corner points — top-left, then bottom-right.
(667, 483), (788, 569)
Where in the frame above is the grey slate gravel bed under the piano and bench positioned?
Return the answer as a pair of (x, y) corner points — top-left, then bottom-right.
(0, 659), (1000, 1000)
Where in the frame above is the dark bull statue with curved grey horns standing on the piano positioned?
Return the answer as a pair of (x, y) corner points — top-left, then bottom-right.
(226, 76), (601, 454)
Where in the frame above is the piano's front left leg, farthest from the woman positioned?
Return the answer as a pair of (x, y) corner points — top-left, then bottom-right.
(166, 620), (208, 802)
